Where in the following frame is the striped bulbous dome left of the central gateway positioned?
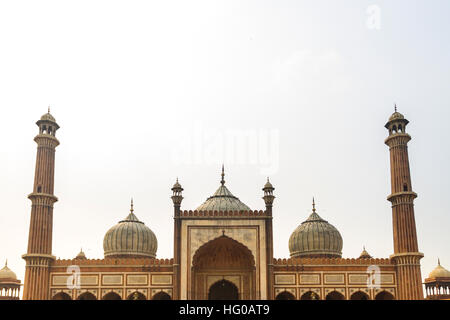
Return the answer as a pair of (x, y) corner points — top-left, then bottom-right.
(103, 201), (158, 258)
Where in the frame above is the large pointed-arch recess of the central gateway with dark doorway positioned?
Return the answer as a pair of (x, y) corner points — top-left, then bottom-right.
(192, 235), (256, 300)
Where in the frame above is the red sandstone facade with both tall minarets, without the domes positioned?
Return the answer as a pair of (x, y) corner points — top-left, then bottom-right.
(23, 112), (423, 300)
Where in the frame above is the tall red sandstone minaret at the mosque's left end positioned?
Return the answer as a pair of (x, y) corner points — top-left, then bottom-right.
(22, 108), (59, 300)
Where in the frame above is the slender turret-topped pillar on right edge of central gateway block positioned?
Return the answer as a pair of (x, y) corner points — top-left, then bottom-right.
(263, 178), (275, 300)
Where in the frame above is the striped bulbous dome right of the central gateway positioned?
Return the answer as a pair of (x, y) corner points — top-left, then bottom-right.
(289, 200), (342, 258)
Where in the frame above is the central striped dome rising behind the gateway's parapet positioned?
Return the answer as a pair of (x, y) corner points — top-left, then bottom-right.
(196, 166), (251, 211)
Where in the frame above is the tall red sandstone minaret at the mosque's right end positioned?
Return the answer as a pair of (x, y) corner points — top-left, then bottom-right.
(384, 107), (423, 300)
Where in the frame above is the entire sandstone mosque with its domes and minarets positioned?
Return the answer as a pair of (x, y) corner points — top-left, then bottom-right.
(0, 110), (450, 300)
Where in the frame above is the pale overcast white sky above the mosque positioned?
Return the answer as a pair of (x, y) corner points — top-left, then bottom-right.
(0, 0), (450, 296)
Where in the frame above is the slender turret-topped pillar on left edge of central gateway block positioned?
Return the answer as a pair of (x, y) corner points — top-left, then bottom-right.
(172, 178), (183, 300)
